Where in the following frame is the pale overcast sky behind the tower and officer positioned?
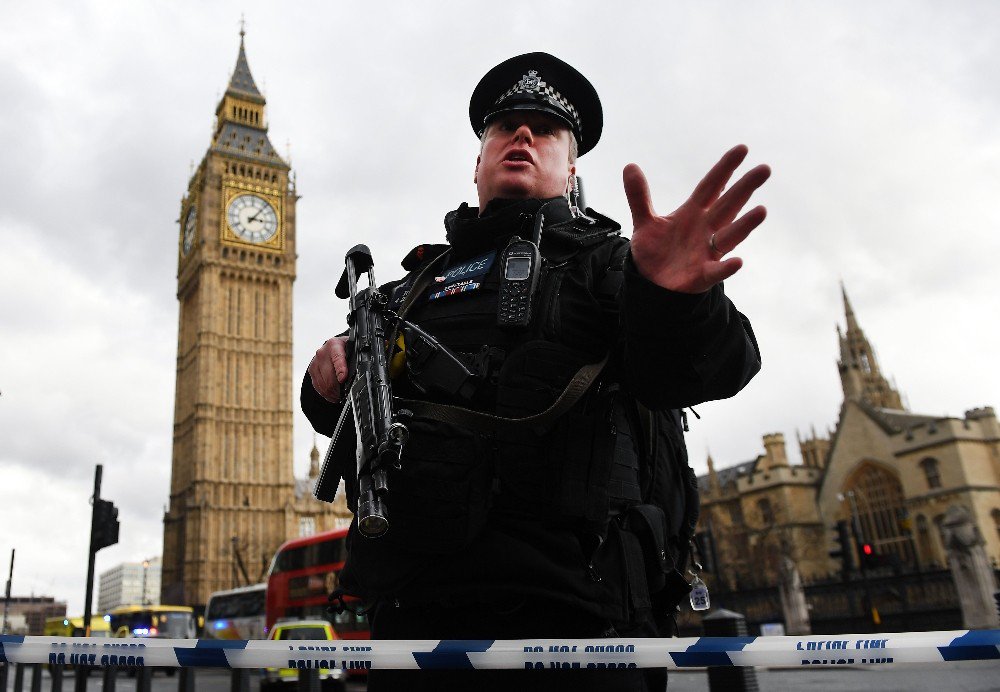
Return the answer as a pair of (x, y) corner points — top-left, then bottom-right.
(0, 0), (1000, 613)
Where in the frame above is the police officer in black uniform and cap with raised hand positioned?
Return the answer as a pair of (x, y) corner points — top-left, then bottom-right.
(302, 53), (770, 692)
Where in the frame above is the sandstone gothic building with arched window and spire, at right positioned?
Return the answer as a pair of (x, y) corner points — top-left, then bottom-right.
(699, 291), (1000, 589)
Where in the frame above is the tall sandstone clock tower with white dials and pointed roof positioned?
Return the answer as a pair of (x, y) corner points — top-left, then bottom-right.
(162, 30), (321, 605)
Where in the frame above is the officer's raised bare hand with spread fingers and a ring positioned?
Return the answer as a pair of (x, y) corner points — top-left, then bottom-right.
(622, 144), (771, 293)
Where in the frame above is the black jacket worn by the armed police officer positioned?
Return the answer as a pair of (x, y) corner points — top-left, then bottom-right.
(302, 199), (760, 621)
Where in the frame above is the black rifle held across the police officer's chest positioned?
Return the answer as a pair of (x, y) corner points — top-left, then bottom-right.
(313, 245), (478, 538)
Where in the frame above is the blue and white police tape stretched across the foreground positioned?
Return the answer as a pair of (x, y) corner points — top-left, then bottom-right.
(0, 630), (1000, 669)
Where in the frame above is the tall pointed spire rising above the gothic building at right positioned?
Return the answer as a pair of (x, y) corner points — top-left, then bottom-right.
(837, 283), (903, 410)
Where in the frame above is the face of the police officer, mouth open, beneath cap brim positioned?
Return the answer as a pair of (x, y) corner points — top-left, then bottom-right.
(475, 111), (576, 209)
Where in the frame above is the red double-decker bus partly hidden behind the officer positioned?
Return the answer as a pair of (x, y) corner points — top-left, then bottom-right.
(267, 528), (369, 639)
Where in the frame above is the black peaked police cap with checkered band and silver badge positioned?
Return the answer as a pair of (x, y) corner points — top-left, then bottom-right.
(469, 53), (604, 156)
